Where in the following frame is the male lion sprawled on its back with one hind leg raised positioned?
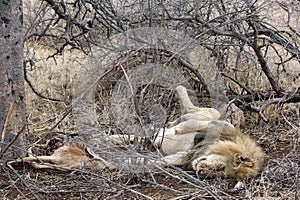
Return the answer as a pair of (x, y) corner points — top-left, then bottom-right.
(109, 86), (265, 180)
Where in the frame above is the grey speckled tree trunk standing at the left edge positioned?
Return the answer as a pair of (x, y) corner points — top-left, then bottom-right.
(0, 0), (26, 159)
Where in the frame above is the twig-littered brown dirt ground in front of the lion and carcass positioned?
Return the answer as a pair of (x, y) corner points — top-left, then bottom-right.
(0, 110), (300, 200)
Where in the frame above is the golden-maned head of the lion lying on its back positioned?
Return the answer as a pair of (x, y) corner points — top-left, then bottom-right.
(190, 121), (265, 180)
